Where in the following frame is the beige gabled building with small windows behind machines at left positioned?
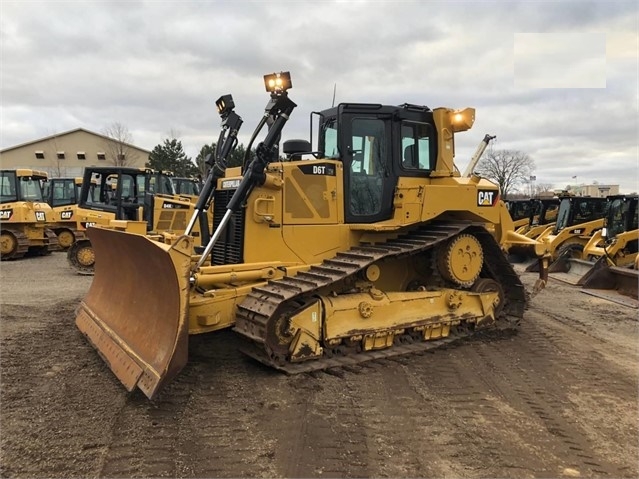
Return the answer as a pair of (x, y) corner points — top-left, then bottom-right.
(0, 128), (151, 178)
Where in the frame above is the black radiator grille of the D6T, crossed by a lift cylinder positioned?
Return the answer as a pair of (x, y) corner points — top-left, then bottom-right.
(211, 190), (245, 265)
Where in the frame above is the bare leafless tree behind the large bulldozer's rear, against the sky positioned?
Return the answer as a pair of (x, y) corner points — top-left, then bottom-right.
(477, 148), (535, 198)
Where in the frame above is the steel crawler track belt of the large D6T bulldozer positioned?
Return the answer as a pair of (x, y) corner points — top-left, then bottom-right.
(234, 222), (526, 374)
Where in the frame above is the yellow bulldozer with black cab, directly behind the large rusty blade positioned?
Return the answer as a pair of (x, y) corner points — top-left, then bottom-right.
(67, 166), (209, 275)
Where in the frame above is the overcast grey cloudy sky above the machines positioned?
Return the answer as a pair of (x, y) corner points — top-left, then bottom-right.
(0, 0), (639, 193)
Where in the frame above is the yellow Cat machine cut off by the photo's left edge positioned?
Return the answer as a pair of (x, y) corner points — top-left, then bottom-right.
(0, 169), (59, 260)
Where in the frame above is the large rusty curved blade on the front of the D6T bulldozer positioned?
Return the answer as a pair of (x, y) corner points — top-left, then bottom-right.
(76, 228), (192, 399)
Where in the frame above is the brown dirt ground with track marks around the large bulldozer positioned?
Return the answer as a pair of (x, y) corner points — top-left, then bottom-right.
(0, 253), (639, 478)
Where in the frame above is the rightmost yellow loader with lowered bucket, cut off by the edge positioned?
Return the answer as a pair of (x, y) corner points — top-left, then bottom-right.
(548, 195), (639, 307)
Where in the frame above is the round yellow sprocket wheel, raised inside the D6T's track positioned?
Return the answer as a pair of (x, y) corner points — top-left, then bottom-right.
(437, 234), (484, 288)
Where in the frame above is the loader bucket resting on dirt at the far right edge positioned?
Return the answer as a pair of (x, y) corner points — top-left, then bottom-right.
(579, 257), (639, 308)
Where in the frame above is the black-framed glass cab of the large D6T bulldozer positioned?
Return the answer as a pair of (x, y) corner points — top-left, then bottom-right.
(319, 103), (437, 223)
